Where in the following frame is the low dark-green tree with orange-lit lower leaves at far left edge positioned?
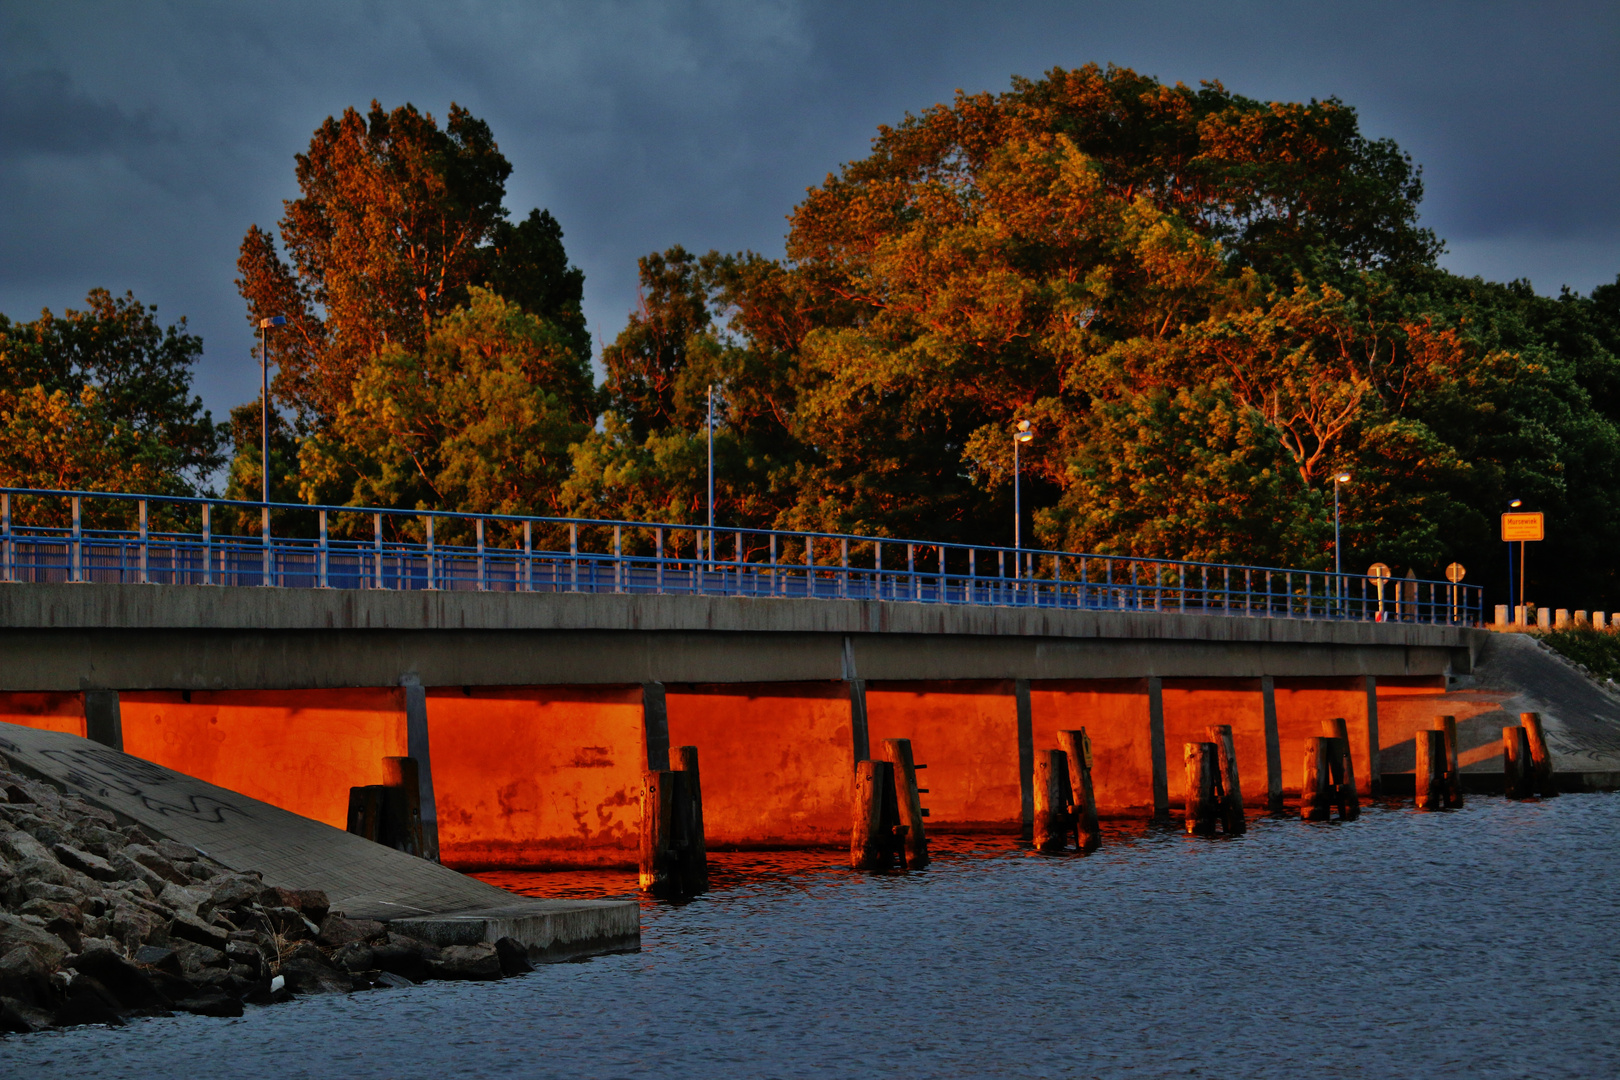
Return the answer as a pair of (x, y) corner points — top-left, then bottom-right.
(0, 288), (224, 514)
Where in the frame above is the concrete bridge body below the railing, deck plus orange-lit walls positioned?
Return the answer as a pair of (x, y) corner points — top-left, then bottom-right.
(0, 583), (1489, 868)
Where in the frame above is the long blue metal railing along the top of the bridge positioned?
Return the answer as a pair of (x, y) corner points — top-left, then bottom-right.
(0, 487), (1482, 625)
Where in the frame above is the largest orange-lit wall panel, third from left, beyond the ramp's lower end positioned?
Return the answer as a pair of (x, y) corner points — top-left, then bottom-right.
(428, 687), (646, 870)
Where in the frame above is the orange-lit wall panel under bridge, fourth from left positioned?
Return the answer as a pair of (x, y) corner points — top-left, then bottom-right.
(664, 682), (855, 848)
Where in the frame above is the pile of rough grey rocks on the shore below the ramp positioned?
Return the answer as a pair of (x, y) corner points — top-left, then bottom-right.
(0, 767), (531, 1033)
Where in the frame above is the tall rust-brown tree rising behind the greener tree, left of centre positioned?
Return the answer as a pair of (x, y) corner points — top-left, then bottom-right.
(237, 102), (590, 429)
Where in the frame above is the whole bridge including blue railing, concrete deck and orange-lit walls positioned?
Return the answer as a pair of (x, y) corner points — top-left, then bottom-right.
(0, 489), (1489, 868)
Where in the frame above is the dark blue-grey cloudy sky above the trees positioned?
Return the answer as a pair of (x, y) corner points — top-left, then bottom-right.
(0, 0), (1620, 416)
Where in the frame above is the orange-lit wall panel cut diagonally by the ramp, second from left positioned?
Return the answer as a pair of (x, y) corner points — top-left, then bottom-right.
(118, 688), (405, 829)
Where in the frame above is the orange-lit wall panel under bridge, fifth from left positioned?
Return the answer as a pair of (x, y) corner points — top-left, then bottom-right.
(867, 682), (1024, 829)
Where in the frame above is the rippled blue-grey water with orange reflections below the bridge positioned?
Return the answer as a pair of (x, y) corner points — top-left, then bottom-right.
(0, 795), (1620, 1080)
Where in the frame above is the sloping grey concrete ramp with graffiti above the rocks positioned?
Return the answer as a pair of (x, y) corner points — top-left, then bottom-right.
(0, 724), (642, 959)
